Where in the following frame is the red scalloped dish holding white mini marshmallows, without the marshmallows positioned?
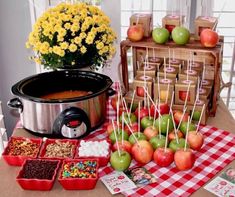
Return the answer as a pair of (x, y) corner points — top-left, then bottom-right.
(74, 139), (111, 167)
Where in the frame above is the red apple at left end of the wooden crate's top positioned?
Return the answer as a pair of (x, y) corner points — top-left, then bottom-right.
(127, 24), (144, 42)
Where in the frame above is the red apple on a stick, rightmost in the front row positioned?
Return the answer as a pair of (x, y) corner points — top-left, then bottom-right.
(174, 149), (195, 170)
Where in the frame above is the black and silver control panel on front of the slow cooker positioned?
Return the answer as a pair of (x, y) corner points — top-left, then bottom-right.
(53, 107), (91, 138)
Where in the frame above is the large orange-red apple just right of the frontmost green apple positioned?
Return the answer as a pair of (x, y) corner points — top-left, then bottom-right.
(131, 140), (153, 164)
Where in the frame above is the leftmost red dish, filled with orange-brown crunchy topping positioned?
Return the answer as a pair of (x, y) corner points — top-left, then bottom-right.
(2, 137), (42, 166)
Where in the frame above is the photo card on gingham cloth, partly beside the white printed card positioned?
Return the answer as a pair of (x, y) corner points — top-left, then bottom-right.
(125, 167), (157, 187)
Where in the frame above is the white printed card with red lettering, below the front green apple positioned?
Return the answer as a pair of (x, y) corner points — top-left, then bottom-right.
(100, 171), (136, 194)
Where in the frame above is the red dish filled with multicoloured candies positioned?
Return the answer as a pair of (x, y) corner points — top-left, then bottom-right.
(58, 159), (99, 190)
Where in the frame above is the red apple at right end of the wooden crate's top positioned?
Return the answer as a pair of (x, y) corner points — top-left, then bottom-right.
(200, 29), (219, 47)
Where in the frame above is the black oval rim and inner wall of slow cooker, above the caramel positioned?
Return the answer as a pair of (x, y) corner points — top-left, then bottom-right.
(12, 70), (112, 103)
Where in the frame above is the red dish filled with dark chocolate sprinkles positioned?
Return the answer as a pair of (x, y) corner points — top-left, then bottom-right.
(16, 159), (61, 191)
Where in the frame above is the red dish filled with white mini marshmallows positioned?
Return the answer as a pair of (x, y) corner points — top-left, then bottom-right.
(74, 140), (111, 167)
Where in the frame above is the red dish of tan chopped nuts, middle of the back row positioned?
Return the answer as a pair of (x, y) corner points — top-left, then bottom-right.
(39, 139), (77, 160)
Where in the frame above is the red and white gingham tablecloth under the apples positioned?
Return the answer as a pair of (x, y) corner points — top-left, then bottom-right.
(15, 84), (235, 197)
